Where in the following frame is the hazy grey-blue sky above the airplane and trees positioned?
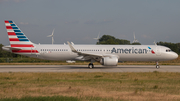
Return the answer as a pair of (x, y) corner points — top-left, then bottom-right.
(0, 0), (180, 45)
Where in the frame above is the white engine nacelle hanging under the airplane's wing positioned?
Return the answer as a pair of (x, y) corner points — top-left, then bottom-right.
(100, 57), (118, 66)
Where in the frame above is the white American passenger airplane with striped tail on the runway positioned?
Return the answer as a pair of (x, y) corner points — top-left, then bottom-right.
(2, 20), (178, 69)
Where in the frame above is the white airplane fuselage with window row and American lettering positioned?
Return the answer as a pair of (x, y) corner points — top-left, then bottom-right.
(9, 44), (178, 61)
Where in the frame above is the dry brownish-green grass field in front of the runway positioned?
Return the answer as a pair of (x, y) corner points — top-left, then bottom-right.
(0, 71), (180, 101)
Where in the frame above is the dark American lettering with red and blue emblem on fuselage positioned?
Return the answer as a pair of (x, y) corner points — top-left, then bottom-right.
(111, 47), (155, 54)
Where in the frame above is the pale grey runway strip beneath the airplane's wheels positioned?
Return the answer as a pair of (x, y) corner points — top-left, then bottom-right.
(0, 65), (180, 72)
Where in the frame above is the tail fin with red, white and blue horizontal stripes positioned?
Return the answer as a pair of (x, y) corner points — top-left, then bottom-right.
(4, 20), (36, 53)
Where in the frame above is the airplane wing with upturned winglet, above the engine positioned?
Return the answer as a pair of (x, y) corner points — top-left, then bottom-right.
(67, 42), (117, 61)
